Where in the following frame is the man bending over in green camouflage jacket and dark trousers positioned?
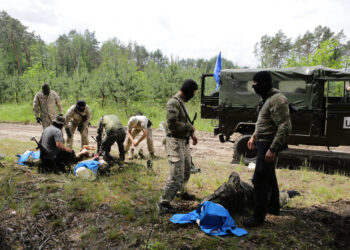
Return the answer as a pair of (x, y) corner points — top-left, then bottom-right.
(96, 115), (126, 162)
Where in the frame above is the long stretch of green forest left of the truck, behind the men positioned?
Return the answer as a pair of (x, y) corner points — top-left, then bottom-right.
(0, 11), (237, 107)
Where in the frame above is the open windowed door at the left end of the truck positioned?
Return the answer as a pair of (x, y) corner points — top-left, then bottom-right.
(201, 74), (219, 119)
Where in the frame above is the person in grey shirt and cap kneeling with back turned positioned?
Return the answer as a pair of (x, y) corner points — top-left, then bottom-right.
(40, 116), (75, 172)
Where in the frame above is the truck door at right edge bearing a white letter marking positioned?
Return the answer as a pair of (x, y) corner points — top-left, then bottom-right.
(325, 81), (350, 145)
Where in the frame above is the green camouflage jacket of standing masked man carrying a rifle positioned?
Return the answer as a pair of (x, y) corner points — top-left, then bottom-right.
(166, 93), (193, 137)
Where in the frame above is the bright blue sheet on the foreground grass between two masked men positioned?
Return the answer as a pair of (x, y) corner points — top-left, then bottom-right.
(170, 201), (248, 237)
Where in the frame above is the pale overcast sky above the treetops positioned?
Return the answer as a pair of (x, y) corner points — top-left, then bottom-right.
(0, 0), (350, 67)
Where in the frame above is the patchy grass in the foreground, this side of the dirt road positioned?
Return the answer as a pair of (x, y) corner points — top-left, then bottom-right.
(0, 139), (350, 249)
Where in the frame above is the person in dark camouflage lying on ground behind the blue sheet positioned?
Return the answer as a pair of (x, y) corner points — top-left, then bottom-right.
(202, 172), (300, 214)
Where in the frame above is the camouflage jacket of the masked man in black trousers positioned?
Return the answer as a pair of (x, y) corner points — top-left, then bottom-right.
(254, 89), (292, 152)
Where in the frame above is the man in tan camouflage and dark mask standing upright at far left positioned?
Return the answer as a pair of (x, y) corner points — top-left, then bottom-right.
(33, 83), (63, 129)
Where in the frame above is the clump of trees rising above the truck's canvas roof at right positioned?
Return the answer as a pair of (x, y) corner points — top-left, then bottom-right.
(254, 26), (350, 69)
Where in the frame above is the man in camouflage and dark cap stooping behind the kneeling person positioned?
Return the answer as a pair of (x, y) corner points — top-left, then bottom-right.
(66, 100), (91, 148)
